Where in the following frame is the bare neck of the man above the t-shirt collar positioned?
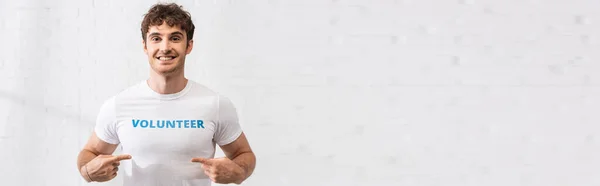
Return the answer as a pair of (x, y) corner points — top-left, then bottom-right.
(146, 73), (188, 94)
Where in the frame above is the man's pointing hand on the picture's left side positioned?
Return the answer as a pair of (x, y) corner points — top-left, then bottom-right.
(81, 154), (131, 182)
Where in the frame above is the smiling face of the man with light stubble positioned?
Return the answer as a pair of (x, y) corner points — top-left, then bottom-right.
(144, 23), (193, 75)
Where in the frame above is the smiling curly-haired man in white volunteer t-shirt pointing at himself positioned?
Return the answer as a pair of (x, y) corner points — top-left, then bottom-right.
(77, 4), (256, 186)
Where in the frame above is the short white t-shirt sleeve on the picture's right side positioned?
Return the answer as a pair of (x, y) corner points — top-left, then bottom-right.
(214, 96), (242, 145)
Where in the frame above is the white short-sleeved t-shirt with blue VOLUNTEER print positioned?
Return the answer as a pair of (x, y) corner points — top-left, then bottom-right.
(95, 80), (242, 186)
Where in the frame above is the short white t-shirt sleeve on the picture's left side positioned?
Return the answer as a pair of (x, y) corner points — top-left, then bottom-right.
(94, 97), (119, 144)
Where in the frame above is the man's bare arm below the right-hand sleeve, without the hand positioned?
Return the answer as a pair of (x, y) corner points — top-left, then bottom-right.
(220, 132), (256, 184)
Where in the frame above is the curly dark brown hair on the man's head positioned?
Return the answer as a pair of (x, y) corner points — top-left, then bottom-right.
(141, 3), (195, 41)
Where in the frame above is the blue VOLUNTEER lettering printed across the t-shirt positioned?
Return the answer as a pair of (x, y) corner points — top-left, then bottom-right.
(131, 119), (204, 128)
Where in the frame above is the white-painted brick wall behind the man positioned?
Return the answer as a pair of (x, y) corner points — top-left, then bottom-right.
(0, 0), (600, 186)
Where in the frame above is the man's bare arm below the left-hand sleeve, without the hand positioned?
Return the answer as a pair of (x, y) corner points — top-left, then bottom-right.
(77, 132), (118, 182)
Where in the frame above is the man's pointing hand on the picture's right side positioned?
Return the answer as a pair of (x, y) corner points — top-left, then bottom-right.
(192, 158), (244, 184)
